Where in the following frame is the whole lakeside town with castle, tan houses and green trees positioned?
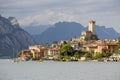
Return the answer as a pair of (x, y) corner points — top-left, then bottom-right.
(15, 20), (120, 62)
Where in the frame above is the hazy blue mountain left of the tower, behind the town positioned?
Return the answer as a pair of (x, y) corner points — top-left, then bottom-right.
(33, 22), (84, 43)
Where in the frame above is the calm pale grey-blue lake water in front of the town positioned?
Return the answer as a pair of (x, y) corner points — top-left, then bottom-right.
(0, 60), (120, 80)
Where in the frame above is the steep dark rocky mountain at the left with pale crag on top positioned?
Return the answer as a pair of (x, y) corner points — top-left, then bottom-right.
(0, 16), (35, 58)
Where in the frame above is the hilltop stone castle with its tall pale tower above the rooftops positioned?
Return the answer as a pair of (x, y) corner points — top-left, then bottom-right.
(72, 20), (98, 42)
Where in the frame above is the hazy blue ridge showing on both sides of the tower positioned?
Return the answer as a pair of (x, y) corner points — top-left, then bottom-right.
(30, 22), (120, 43)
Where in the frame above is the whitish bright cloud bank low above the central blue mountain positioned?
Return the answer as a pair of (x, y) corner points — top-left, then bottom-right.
(19, 10), (76, 26)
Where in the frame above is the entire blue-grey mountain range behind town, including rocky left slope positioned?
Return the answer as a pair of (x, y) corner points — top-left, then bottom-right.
(0, 15), (120, 58)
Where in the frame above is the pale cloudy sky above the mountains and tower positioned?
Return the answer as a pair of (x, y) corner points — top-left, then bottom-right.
(0, 0), (120, 32)
